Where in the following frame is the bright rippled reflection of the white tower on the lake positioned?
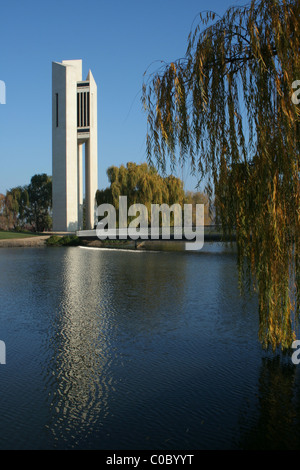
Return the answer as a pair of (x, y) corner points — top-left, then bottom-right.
(50, 248), (113, 442)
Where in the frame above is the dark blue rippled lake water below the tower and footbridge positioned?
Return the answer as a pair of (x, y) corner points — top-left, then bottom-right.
(0, 243), (300, 450)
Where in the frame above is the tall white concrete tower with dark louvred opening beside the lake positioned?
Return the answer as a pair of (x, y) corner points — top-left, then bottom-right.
(52, 60), (98, 232)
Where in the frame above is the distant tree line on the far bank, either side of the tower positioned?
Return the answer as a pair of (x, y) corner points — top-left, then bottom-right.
(0, 162), (212, 232)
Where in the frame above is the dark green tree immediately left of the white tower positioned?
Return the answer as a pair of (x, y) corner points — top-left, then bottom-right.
(26, 173), (52, 232)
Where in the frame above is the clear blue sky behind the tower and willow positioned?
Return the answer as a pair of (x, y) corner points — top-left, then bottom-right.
(0, 0), (244, 193)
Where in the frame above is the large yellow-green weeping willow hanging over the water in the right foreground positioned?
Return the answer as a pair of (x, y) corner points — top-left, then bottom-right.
(143, 0), (300, 350)
